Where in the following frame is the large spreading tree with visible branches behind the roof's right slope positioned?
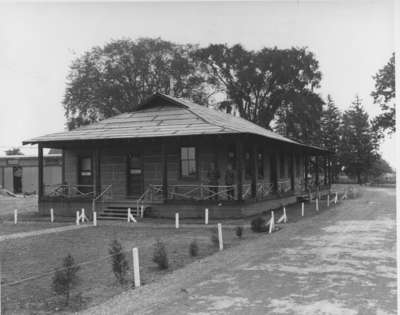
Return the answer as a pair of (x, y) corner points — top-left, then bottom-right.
(195, 44), (321, 129)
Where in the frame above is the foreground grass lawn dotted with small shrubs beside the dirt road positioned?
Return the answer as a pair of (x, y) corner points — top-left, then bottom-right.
(0, 224), (257, 314)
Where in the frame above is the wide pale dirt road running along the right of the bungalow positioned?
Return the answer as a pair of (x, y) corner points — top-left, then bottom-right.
(79, 188), (396, 315)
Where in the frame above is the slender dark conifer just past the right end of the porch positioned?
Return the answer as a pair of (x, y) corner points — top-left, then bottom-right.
(321, 95), (342, 178)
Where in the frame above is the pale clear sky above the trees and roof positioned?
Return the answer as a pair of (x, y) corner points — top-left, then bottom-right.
(0, 0), (396, 166)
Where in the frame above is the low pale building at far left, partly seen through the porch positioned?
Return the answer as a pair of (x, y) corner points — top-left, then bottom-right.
(0, 154), (62, 194)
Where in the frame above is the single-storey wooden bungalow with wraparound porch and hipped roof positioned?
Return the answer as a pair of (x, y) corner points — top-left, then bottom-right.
(24, 93), (330, 218)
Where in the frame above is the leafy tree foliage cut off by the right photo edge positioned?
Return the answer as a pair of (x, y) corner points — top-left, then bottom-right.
(371, 53), (396, 133)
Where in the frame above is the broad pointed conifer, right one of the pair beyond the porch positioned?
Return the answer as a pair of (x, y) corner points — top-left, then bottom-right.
(339, 96), (379, 184)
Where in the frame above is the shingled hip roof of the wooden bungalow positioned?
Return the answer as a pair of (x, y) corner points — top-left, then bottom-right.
(24, 93), (328, 150)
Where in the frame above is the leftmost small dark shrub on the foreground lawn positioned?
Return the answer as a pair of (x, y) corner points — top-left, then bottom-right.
(52, 254), (80, 306)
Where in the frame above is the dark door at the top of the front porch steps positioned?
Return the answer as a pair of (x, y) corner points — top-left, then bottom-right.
(127, 152), (144, 198)
